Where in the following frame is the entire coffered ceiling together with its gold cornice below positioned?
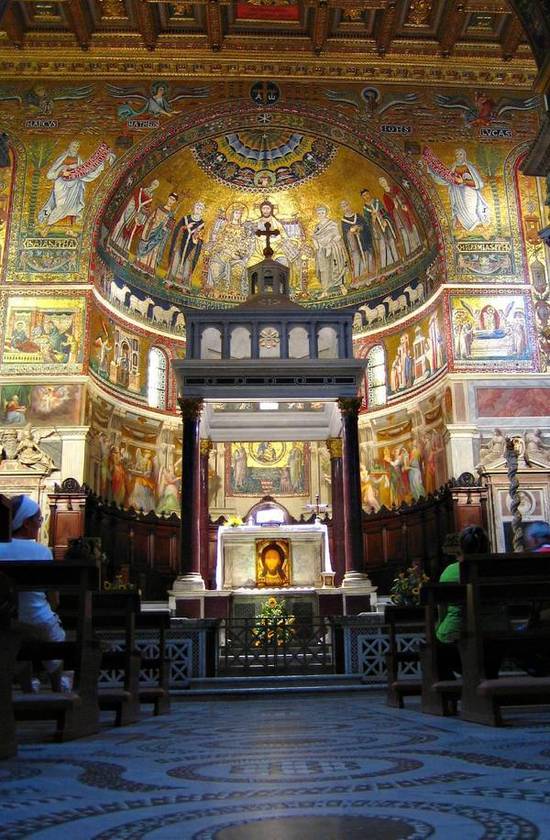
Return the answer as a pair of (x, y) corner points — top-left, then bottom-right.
(0, 0), (537, 87)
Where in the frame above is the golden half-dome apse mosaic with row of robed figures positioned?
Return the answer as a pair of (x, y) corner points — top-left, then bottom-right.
(101, 126), (433, 306)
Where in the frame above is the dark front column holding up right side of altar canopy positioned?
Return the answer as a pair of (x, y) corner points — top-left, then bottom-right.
(338, 397), (370, 587)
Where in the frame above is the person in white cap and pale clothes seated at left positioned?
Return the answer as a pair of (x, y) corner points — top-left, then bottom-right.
(0, 495), (72, 691)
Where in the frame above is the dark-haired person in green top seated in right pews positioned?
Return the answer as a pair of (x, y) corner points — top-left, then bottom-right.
(435, 525), (509, 680)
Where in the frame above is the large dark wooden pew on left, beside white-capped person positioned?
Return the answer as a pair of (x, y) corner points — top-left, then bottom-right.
(0, 561), (100, 741)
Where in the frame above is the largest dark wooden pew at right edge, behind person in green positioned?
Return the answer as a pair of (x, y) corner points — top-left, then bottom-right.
(460, 553), (550, 726)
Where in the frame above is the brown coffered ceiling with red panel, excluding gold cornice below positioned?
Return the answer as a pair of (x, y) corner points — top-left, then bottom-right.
(0, 0), (540, 76)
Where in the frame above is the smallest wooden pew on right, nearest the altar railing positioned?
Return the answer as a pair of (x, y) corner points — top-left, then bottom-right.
(384, 606), (424, 709)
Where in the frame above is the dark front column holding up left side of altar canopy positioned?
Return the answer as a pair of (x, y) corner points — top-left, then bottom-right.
(174, 399), (205, 591)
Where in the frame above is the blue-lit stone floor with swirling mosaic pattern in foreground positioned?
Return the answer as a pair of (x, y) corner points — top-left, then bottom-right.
(0, 692), (550, 840)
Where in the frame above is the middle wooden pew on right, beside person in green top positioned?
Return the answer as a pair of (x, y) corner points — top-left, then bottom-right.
(420, 583), (466, 717)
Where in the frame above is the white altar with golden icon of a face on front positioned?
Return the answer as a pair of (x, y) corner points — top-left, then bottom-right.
(216, 523), (332, 595)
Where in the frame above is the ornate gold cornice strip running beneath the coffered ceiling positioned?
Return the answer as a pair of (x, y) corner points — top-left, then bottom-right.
(0, 50), (537, 89)
